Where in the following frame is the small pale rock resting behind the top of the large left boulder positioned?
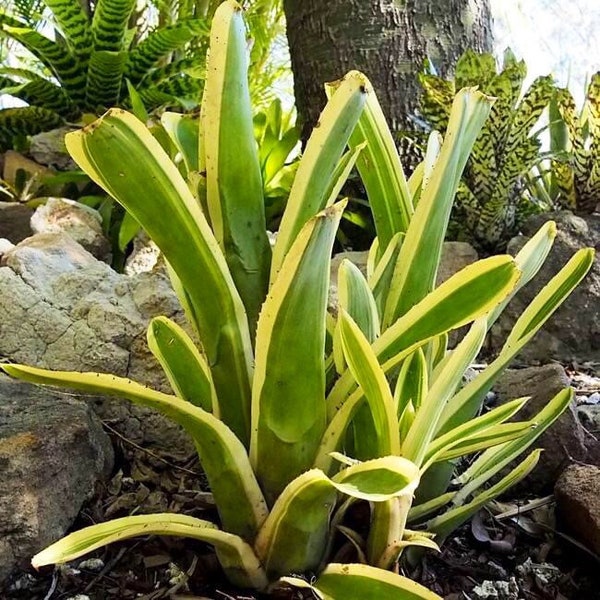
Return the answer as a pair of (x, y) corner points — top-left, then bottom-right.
(31, 198), (110, 262)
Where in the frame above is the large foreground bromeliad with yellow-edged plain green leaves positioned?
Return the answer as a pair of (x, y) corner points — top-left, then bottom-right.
(2, 1), (593, 600)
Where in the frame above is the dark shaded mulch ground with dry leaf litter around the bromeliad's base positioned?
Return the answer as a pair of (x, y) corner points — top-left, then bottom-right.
(0, 364), (600, 600)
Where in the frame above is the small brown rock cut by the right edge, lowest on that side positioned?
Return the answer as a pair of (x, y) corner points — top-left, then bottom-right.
(554, 465), (600, 554)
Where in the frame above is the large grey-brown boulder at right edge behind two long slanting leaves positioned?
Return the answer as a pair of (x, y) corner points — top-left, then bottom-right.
(490, 211), (600, 364)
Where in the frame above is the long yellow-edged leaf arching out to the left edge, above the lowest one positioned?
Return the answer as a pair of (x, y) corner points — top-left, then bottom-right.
(1, 365), (267, 540)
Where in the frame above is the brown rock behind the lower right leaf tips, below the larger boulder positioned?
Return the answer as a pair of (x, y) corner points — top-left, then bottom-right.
(494, 364), (587, 493)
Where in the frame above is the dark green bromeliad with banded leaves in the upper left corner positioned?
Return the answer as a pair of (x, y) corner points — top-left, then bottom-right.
(0, 0), (209, 148)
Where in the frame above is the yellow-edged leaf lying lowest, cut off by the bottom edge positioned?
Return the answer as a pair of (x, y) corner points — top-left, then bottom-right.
(282, 563), (442, 600)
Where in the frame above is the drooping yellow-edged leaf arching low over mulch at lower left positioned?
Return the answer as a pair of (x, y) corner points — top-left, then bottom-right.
(31, 513), (267, 589)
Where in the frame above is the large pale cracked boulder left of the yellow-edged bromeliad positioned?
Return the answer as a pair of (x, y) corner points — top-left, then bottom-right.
(0, 233), (193, 453)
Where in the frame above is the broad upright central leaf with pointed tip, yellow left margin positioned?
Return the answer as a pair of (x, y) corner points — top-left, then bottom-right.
(250, 202), (345, 500)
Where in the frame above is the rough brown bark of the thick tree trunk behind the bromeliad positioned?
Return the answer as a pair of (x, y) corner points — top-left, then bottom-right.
(284, 0), (491, 140)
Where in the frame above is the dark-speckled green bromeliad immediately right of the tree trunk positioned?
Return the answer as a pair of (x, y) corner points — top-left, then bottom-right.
(420, 50), (554, 252)
